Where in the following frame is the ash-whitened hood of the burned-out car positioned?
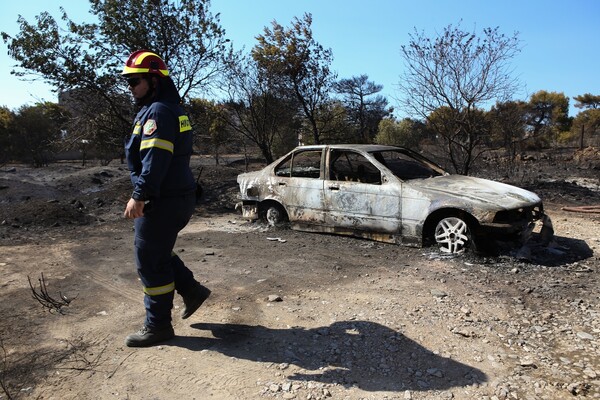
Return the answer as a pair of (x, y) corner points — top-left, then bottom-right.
(405, 175), (541, 209)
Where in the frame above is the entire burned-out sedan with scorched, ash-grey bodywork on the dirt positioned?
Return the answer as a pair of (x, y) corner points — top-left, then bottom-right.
(237, 144), (551, 254)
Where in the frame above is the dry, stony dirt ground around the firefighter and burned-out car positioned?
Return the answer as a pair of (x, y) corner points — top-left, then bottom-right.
(0, 160), (600, 400)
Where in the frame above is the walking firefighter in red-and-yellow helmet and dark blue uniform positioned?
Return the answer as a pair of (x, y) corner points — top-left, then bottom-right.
(122, 50), (210, 347)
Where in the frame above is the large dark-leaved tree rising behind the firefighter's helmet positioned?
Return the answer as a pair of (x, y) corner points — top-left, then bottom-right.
(2, 0), (230, 162)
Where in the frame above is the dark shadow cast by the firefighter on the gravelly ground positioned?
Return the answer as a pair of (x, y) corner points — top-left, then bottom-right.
(170, 321), (487, 391)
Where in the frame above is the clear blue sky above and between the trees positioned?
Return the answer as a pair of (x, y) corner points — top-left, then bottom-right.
(0, 0), (600, 116)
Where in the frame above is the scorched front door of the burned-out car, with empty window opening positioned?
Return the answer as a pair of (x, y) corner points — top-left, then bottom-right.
(324, 149), (402, 234)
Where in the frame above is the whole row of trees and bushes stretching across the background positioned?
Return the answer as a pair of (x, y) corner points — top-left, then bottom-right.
(0, 0), (600, 165)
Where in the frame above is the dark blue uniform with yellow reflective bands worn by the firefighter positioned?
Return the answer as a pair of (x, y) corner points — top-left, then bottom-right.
(125, 101), (197, 328)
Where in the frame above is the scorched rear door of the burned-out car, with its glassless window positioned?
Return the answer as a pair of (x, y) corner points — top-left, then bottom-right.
(272, 149), (325, 225)
